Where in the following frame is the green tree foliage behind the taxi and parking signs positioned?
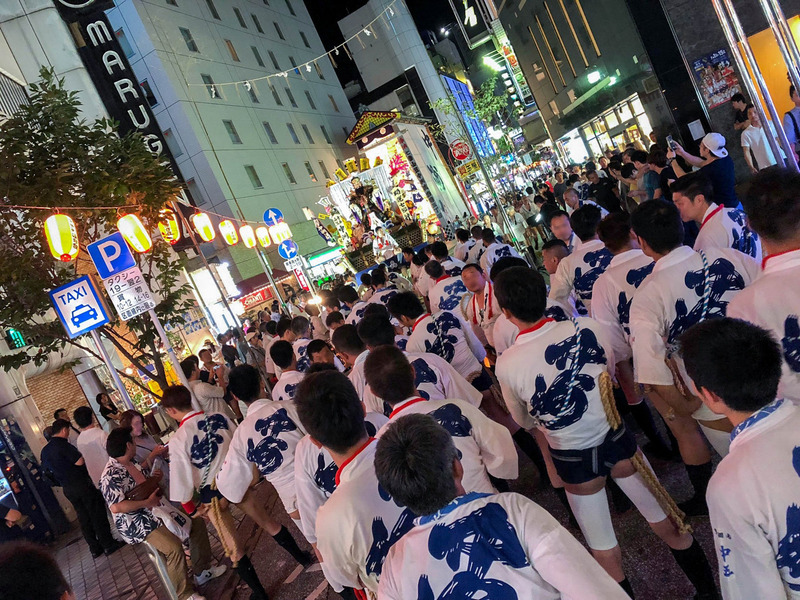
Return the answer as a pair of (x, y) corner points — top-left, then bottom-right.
(0, 68), (193, 388)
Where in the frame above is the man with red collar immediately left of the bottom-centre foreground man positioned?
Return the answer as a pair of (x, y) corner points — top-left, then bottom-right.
(295, 370), (414, 598)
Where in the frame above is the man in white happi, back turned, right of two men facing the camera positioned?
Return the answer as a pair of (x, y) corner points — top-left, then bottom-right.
(549, 205), (611, 316)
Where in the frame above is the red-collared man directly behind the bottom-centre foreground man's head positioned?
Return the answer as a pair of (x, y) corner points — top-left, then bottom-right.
(364, 346), (519, 494)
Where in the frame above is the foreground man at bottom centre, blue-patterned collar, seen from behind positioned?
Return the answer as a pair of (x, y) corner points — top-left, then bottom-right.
(375, 414), (628, 600)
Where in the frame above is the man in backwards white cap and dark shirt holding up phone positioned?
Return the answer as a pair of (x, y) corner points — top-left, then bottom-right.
(667, 132), (739, 208)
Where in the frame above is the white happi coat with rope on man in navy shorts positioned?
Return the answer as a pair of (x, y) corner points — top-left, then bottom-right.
(496, 318), (615, 450)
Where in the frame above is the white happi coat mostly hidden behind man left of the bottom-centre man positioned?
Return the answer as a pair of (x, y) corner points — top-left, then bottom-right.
(294, 413), (389, 544)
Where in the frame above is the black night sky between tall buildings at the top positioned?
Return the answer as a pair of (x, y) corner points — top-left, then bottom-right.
(305, 0), (455, 85)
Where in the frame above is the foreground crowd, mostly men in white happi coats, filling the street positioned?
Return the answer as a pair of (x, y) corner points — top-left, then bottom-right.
(10, 167), (800, 600)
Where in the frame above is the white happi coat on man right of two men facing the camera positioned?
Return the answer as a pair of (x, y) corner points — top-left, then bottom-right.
(548, 240), (611, 315)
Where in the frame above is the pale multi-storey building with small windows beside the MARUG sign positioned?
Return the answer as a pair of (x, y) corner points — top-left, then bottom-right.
(107, 0), (355, 291)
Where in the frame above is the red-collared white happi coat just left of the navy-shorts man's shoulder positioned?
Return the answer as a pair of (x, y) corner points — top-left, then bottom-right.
(406, 311), (485, 381)
